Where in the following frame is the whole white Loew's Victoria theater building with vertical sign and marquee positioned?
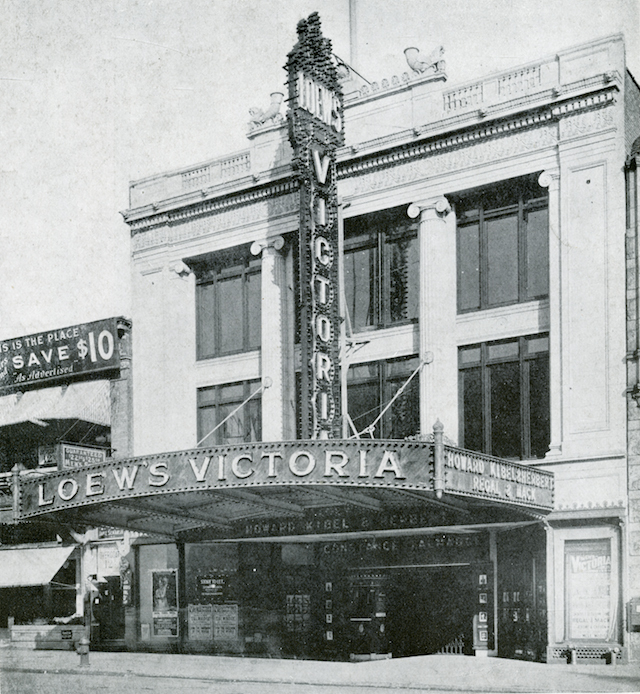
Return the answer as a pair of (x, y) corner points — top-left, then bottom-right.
(12, 15), (640, 662)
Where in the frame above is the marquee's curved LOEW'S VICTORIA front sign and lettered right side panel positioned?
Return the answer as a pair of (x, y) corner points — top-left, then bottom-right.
(17, 440), (553, 520)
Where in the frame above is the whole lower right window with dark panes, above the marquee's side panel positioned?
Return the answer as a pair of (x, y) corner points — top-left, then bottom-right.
(458, 335), (549, 459)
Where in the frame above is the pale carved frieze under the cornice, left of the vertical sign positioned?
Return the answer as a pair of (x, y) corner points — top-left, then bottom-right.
(131, 192), (300, 252)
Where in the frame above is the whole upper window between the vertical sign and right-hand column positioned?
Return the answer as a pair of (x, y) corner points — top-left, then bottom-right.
(344, 207), (420, 331)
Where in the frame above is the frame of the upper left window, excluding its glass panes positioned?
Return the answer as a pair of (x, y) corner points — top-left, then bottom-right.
(194, 249), (262, 361)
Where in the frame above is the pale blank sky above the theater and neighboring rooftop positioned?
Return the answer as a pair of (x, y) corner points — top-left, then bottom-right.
(0, 0), (640, 339)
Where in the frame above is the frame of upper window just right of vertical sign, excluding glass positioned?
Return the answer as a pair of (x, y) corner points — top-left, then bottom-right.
(343, 206), (420, 332)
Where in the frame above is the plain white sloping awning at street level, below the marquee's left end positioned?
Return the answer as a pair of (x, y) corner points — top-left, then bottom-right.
(0, 545), (75, 588)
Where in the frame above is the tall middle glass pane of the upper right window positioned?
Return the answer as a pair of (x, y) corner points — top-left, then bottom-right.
(485, 215), (518, 306)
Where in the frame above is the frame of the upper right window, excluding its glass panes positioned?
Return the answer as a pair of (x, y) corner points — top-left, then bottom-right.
(452, 178), (549, 314)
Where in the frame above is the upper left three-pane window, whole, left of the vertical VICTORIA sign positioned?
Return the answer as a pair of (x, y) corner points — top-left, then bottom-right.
(194, 252), (261, 359)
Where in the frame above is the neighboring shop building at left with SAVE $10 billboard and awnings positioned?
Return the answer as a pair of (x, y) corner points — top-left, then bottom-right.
(0, 319), (131, 647)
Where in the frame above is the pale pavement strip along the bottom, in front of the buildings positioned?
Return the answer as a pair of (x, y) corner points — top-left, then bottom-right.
(0, 641), (640, 692)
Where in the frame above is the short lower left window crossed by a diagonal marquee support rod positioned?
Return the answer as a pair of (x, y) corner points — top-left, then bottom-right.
(198, 381), (262, 446)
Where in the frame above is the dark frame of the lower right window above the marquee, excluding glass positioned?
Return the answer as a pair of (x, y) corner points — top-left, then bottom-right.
(458, 333), (551, 460)
